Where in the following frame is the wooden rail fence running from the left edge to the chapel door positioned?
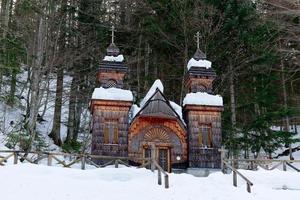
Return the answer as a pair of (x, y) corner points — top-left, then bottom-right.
(0, 150), (169, 188)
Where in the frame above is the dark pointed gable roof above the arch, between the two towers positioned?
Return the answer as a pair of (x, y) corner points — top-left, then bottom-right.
(132, 88), (185, 127)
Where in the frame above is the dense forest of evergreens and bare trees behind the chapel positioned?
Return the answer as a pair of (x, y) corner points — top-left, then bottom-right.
(0, 0), (300, 156)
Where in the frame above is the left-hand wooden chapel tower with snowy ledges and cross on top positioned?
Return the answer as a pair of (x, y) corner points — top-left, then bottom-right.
(90, 27), (133, 164)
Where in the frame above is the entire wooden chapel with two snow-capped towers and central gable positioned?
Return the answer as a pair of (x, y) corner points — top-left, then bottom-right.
(90, 28), (223, 171)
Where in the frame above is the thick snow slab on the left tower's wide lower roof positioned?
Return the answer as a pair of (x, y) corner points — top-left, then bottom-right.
(92, 87), (133, 101)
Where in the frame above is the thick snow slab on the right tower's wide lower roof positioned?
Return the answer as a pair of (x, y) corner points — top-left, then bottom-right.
(183, 92), (223, 106)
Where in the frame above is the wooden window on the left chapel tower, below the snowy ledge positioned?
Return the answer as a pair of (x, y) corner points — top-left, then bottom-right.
(103, 121), (119, 144)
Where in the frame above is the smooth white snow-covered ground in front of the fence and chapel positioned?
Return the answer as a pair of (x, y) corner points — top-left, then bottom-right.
(0, 164), (300, 200)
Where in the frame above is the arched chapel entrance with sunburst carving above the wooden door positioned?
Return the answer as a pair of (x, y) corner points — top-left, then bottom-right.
(129, 124), (186, 171)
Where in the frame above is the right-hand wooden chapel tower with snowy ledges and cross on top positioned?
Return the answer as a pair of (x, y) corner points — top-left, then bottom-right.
(183, 32), (223, 168)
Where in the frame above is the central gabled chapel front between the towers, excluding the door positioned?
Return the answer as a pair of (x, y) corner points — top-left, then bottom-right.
(128, 89), (188, 167)
